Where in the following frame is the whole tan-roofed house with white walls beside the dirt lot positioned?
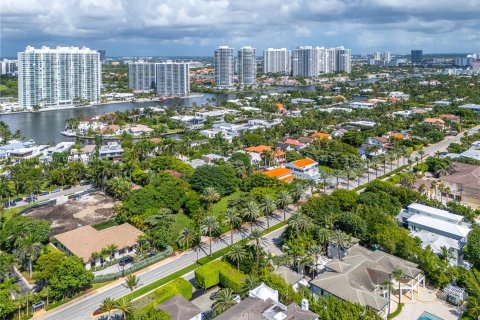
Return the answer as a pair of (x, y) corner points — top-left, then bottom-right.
(53, 223), (143, 270)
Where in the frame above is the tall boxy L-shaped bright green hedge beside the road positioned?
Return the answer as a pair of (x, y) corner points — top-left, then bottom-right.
(195, 260), (245, 292)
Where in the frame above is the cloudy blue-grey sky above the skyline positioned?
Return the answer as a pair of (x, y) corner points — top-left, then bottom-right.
(0, 0), (480, 57)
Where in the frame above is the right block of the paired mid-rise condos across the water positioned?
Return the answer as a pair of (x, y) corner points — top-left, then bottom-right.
(155, 61), (190, 96)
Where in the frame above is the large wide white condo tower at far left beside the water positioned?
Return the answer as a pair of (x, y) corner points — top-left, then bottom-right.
(18, 46), (102, 108)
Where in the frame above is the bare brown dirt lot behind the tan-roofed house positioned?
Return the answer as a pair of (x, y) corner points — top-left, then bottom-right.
(27, 192), (117, 235)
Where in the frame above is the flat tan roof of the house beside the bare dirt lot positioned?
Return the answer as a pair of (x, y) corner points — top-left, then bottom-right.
(55, 223), (143, 263)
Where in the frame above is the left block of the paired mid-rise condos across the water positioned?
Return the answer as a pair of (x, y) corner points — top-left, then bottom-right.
(128, 61), (157, 91)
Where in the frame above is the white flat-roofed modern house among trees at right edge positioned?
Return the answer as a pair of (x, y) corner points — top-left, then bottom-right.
(397, 203), (471, 265)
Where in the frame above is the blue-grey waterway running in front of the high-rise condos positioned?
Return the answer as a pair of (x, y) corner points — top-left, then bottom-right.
(0, 86), (315, 144)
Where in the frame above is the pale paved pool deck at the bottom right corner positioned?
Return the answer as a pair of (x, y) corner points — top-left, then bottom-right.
(391, 287), (465, 320)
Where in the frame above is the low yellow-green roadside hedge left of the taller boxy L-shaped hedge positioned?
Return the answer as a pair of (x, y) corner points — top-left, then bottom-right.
(133, 278), (193, 310)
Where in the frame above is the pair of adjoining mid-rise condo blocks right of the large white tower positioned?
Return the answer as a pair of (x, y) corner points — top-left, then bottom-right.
(128, 61), (190, 96)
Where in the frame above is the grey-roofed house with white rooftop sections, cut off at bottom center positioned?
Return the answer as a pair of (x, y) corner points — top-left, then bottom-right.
(214, 283), (318, 320)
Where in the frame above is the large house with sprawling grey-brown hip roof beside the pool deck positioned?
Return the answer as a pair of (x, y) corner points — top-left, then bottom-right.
(310, 244), (425, 319)
